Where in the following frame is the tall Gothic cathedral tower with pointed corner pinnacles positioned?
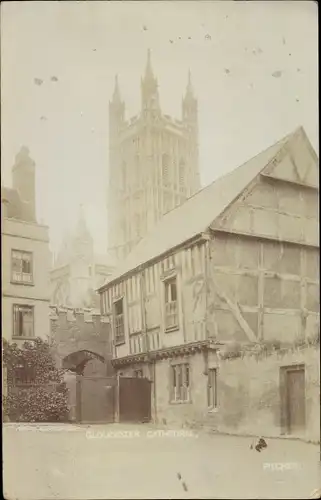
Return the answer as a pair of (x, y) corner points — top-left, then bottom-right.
(108, 51), (200, 259)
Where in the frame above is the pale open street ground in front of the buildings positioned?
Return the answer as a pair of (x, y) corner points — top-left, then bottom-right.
(3, 424), (320, 500)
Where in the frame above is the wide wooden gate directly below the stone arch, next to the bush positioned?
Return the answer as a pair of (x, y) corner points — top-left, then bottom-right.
(76, 375), (116, 424)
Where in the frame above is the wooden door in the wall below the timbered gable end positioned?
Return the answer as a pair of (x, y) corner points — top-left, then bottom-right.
(282, 365), (305, 434)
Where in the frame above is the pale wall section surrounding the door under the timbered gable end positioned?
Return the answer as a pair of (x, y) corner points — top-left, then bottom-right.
(206, 347), (320, 441)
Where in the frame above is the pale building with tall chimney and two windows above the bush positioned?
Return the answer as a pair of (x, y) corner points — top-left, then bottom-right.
(1, 148), (50, 342)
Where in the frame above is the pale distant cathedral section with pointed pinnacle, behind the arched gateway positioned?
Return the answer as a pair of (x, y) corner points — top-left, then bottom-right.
(50, 207), (114, 309)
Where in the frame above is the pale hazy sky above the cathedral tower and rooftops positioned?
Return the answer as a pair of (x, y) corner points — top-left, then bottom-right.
(1, 1), (319, 253)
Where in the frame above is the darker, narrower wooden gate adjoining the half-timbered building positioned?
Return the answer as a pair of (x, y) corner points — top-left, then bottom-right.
(119, 377), (151, 422)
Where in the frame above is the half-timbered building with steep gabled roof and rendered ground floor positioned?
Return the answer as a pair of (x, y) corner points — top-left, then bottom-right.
(100, 128), (320, 435)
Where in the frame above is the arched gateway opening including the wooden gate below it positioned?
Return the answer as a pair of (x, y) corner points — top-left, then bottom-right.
(62, 350), (115, 423)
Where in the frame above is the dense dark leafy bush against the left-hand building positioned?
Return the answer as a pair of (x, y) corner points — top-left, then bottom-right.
(3, 338), (68, 422)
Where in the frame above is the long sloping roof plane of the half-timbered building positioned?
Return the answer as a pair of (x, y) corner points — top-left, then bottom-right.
(100, 127), (302, 290)
